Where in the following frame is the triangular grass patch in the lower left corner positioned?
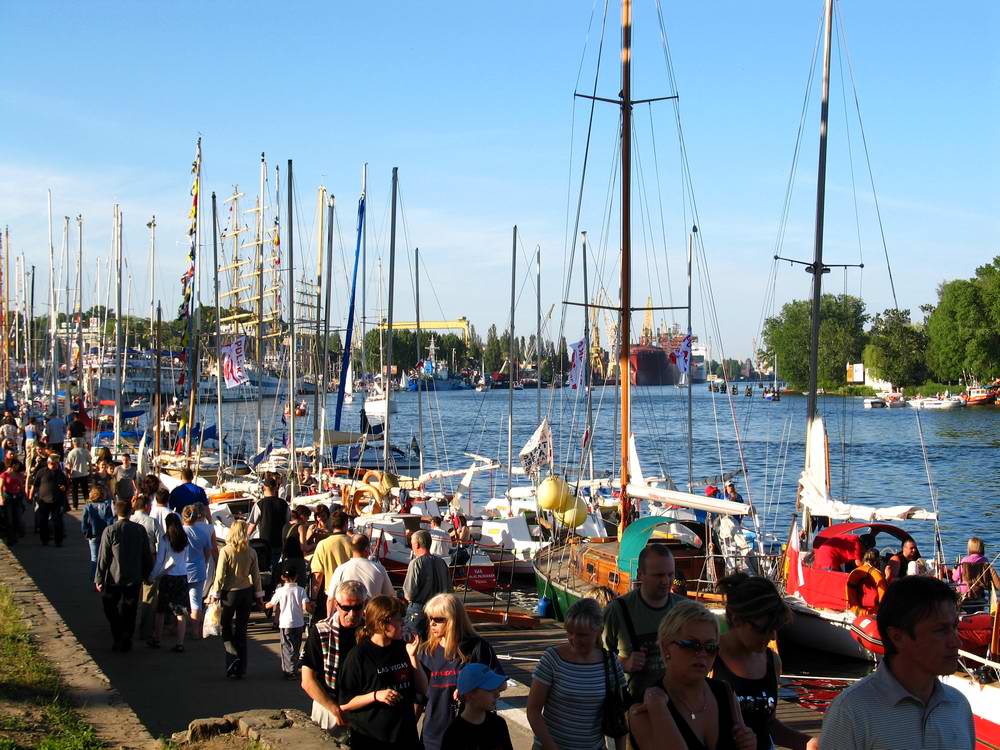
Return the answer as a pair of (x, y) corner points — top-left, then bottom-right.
(0, 585), (104, 750)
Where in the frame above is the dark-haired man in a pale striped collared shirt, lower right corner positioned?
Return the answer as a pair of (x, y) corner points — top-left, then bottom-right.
(820, 576), (976, 750)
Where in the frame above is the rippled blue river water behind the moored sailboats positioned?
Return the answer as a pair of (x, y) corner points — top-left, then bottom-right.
(215, 385), (1000, 560)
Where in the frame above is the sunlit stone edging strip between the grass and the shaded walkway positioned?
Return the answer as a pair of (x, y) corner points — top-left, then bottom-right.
(0, 543), (159, 748)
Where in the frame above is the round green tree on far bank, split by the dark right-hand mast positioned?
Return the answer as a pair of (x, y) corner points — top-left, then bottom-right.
(764, 294), (868, 389)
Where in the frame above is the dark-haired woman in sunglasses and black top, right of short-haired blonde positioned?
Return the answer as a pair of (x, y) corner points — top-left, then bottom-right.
(712, 573), (819, 750)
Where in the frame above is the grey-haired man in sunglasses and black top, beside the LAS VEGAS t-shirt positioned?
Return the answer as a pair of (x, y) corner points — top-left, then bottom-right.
(301, 581), (368, 748)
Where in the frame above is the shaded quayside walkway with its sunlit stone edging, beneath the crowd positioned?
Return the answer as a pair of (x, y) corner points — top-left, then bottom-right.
(0, 512), (532, 750)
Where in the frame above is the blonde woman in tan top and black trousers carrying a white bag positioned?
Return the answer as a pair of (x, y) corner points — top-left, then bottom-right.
(209, 520), (264, 679)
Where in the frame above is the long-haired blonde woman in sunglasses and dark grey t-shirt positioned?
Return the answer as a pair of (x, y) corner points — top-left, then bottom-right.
(417, 594), (504, 750)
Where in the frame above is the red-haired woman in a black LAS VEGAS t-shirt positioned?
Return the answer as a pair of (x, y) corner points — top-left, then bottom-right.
(338, 596), (427, 750)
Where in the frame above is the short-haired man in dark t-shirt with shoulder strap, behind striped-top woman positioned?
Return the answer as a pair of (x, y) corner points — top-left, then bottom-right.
(604, 543), (675, 702)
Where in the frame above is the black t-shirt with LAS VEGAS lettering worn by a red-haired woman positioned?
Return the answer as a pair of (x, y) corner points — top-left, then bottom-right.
(337, 640), (420, 750)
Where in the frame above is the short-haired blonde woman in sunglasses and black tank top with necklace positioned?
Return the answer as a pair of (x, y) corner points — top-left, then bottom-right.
(629, 599), (757, 750)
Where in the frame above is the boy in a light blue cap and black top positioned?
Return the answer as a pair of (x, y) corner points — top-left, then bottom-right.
(441, 663), (513, 750)
